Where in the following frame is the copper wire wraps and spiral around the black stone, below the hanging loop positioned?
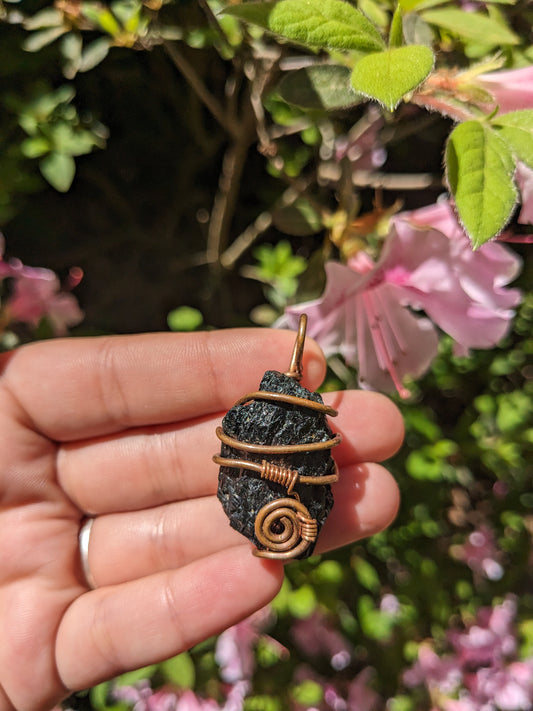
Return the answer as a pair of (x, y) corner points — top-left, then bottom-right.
(213, 391), (341, 560)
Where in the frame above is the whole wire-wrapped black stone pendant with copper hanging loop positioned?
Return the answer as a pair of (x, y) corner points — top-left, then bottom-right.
(213, 315), (341, 560)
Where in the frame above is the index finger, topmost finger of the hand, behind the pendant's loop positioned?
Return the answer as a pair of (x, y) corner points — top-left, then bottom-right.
(0, 329), (325, 442)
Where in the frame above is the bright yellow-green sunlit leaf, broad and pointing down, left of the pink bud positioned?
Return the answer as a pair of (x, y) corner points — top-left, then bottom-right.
(352, 45), (434, 111)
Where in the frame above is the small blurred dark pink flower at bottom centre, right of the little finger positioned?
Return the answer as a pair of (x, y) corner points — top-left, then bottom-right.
(291, 612), (352, 671)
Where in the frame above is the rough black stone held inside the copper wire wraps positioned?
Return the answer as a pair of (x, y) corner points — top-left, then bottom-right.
(218, 370), (334, 558)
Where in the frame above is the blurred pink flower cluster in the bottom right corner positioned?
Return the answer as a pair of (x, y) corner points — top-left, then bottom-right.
(404, 597), (533, 711)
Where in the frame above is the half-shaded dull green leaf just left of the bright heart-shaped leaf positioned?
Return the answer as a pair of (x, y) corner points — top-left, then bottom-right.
(277, 64), (363, 111)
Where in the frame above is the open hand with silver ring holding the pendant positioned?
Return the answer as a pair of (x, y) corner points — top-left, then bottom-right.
(0, 329), (402, 711)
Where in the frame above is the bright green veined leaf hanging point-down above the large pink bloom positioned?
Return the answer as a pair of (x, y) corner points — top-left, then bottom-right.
(445, 121), (517, 248)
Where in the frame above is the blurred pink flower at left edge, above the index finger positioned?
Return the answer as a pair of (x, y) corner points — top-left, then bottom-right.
(0, 238), (83, 336)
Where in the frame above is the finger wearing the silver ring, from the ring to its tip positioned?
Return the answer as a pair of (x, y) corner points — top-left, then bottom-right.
(79, 464), (398, 587)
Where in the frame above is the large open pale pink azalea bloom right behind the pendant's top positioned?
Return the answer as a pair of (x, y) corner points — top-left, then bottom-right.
(277, 201), (520, 396)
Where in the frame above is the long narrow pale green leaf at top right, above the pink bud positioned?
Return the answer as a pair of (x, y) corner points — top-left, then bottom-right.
(421, 8), (520, 46)
